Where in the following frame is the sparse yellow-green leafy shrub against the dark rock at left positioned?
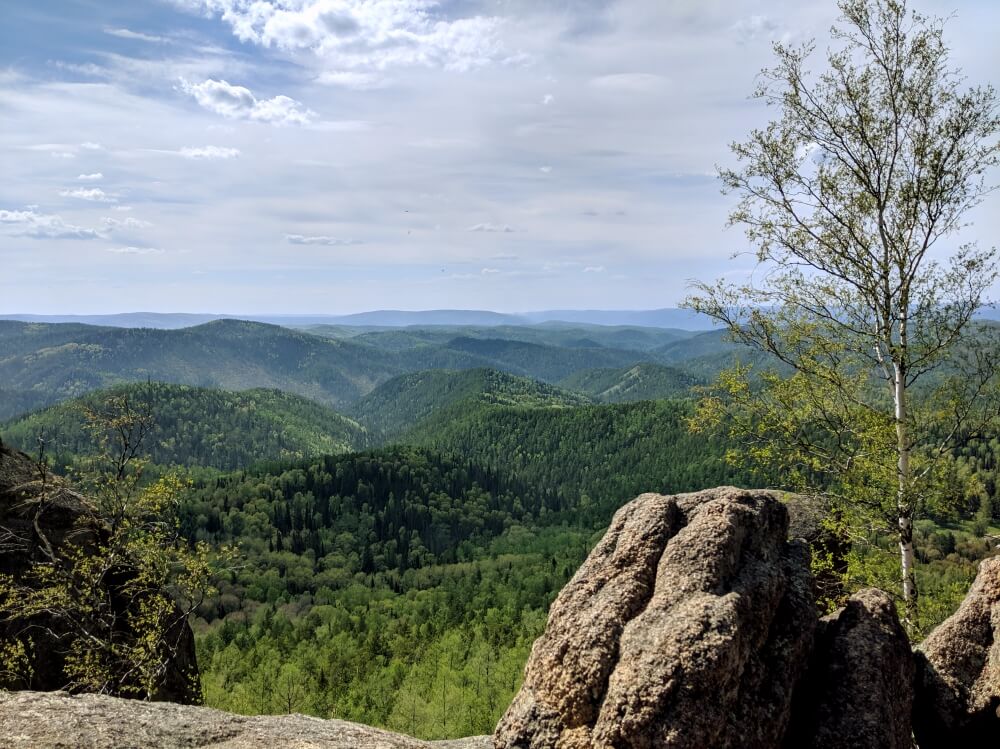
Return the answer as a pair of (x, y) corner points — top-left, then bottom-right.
(0, 395), (228, 699)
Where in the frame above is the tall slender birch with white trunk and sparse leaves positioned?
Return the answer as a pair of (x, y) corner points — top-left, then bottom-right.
(687, 0), (1000, 617)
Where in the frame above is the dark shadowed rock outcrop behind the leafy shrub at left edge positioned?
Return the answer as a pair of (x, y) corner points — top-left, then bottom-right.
(0, 444), (201, 704)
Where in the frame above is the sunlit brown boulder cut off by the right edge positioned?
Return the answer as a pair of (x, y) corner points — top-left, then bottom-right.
(913, 557), (1000, 747)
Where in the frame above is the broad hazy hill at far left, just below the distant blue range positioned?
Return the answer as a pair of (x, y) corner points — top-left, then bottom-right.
(0, 320), (399, 405)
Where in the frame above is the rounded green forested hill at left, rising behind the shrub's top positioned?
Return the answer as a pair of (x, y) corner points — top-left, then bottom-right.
(0, 383), (368, 470)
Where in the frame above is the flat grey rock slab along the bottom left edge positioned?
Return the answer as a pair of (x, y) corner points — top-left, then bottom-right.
(0, 692), (490, 749)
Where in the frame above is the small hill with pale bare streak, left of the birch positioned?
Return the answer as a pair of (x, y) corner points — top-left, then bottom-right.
(559, 363), (699, 403)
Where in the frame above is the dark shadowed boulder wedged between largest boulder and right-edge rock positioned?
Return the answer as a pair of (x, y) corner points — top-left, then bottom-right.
(785, 589), (914, 749)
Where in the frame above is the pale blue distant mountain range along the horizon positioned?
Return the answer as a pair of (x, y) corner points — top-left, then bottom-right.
(0, 307), (713, 330)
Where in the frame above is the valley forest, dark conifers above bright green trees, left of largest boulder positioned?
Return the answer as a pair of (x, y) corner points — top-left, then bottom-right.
(182, 448), (592, 737)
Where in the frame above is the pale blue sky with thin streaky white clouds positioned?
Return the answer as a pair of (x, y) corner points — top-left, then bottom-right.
(0, 0), (1000, 314)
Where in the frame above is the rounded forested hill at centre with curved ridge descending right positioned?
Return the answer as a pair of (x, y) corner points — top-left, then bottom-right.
(349, 369), (590, 442)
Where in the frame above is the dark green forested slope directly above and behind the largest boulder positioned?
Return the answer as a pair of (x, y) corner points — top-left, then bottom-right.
(407, 401), (766, 524)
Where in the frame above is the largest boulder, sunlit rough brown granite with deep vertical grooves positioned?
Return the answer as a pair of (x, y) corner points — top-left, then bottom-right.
(495, 488), (816, 749)
